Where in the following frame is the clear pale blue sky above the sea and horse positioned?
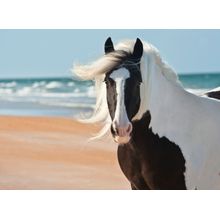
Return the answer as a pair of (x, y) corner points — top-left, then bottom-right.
(0, 29), (220, 78)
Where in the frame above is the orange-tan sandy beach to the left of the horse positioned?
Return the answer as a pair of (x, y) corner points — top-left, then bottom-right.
(0, 116), (130, 189)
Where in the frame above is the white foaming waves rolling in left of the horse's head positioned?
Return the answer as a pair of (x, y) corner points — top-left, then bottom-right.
(0, 78), (95, 111)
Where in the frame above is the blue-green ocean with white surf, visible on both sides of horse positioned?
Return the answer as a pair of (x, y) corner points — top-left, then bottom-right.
(0, 73), (220, 118)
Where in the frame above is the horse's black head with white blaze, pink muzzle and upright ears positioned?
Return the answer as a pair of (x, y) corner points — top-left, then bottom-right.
(104, 38), (143, 144)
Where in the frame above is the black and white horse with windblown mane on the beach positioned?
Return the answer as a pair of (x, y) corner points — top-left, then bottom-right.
(73, 38), (220, 190)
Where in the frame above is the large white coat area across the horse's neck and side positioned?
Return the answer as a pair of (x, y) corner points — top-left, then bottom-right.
(148, 58), (220, 189)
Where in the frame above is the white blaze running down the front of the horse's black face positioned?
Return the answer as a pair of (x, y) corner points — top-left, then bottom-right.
(110, 68), (130, 130)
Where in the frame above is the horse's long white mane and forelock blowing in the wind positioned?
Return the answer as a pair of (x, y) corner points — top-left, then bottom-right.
(72, 40), (180, 138)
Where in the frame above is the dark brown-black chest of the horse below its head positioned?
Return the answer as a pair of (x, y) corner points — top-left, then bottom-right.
(118, 114), (186, 189)
